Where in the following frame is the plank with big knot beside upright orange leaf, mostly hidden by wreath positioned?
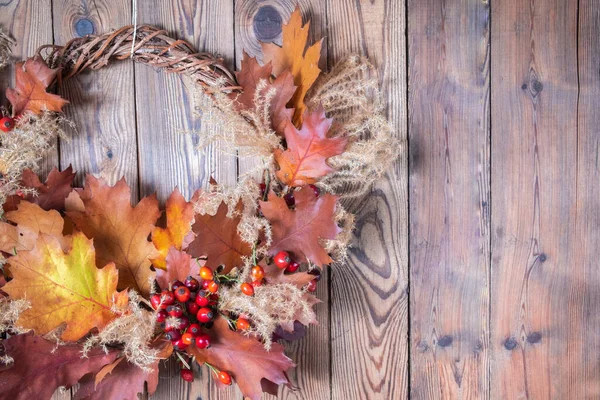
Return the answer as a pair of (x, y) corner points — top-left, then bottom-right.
(235, 0), (330, 400)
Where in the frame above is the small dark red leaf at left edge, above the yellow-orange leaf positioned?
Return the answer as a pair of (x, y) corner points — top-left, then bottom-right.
(4, 165), (75, 212)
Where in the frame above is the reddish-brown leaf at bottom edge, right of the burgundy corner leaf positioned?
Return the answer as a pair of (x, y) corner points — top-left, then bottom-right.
(74, 358), (159, 400)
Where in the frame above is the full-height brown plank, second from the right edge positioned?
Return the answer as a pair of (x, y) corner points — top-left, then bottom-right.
(408, 0), (490, 399)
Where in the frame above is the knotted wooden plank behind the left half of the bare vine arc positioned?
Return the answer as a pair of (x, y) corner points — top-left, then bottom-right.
(53, 0), (138, 200)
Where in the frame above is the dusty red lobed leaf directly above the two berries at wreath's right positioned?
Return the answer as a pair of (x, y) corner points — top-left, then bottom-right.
(259, 186), (341, 266)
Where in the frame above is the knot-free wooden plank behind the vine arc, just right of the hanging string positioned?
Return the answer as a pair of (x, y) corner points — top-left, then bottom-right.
(135, 0), (237, 206)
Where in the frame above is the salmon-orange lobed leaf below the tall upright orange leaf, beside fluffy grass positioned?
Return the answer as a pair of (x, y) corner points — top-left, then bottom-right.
(275, 108), (347, 186)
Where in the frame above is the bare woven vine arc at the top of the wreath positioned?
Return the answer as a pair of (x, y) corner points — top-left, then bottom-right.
(37, 25), (240, 93)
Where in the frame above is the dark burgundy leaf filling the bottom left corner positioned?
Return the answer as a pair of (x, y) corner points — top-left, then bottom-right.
(0, 333), (119, 400)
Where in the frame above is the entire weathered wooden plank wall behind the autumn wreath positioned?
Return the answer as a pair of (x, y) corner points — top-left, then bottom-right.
(0, 0), (600, 400)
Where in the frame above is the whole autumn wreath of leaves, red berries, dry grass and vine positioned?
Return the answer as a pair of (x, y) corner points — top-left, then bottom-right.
(0, 10), (398, 399)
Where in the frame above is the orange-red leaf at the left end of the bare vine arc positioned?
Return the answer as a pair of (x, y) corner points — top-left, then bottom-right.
(6, 57), (69, 115)
